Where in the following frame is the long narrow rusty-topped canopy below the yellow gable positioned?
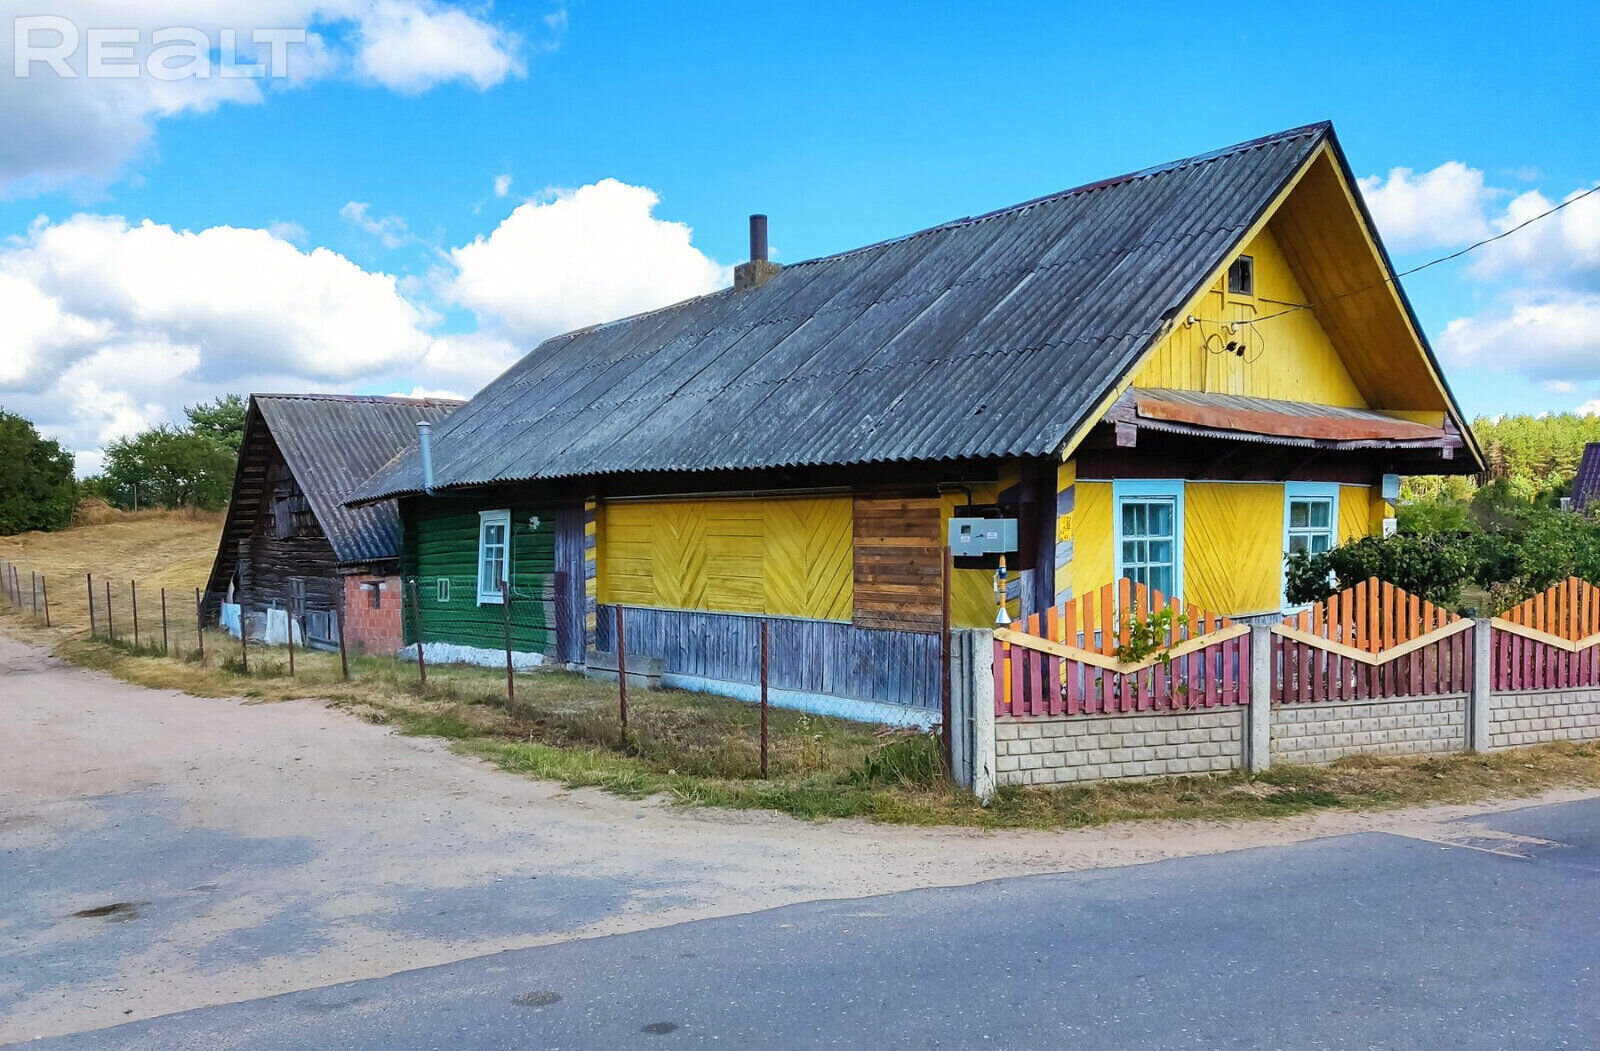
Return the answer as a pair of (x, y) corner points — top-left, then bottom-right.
(1104, 387), (1474, 470)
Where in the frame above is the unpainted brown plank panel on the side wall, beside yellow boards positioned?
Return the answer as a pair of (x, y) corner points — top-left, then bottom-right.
(854, 493), (944, 632)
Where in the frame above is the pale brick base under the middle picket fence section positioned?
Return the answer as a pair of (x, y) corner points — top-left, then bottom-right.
(1272, 694), (1467, 763)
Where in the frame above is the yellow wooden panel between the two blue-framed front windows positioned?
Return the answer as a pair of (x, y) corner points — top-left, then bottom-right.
(1181, 482), (1283, 616)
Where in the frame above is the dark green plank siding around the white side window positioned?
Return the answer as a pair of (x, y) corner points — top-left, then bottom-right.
(400, 498), (555, 656)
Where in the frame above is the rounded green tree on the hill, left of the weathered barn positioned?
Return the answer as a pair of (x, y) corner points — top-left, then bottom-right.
(104, 426), (237, 510)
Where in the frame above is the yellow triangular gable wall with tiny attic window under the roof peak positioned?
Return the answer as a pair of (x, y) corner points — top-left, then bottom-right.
(1133, 227), (1366, 408)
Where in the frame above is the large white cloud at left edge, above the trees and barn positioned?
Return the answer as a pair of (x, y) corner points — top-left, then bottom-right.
(0, 216), (437, 467)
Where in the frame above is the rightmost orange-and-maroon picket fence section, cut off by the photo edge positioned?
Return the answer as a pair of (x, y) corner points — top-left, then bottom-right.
(1491, 577), (1600, 693)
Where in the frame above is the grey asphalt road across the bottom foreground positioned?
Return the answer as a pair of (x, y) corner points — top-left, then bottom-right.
(30, 800), (1600, 1048)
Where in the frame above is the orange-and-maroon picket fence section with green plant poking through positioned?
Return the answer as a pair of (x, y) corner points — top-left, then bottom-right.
(994, 581), (1250, 717)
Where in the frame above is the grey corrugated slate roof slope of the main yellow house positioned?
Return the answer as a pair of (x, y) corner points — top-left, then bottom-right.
(360, 123), (1331, 499)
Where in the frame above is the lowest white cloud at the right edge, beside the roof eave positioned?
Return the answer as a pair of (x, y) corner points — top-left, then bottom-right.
(1437, 290), (1600, 384)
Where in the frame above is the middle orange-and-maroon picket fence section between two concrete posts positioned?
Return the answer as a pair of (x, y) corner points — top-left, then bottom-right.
(1272, 577), (1472, 704)
